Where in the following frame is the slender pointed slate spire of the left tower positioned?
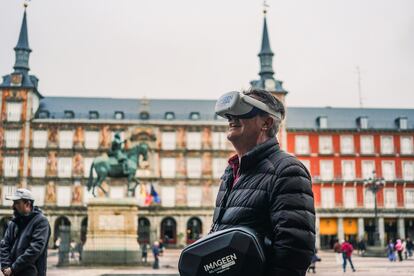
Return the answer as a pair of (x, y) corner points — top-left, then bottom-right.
(13, 4), (32, 72)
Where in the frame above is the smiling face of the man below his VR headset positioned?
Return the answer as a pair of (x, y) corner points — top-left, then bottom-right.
(227, 116), (265, 145)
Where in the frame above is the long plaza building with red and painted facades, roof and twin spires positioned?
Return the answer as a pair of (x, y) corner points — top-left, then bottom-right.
(0, 9), (414, 248)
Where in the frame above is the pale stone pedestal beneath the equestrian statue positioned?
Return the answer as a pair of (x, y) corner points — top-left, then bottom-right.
(82, 198), (141, 265)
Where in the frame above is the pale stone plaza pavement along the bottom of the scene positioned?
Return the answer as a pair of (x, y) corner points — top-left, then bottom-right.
(47, 250), (414, 276)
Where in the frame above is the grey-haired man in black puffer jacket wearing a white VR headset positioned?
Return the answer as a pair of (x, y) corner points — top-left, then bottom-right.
(212, 90), (315, 276)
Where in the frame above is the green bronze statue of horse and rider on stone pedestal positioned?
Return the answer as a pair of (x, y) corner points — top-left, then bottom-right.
(88, 132), (148, 197)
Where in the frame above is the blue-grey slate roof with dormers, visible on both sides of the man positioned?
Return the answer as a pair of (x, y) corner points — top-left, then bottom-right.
(36, 97), (414, 130)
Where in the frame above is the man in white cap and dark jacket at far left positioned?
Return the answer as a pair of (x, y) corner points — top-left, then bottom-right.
(0, 189), (50, 276)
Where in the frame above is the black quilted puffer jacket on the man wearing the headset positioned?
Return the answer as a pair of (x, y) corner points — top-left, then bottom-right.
(213, 139), (315, 276)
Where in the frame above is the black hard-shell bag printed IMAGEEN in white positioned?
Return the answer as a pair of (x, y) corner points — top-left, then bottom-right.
(178, 227), (265, 276)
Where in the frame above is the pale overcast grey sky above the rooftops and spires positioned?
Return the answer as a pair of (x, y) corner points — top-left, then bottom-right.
(0, 0), (414, 108)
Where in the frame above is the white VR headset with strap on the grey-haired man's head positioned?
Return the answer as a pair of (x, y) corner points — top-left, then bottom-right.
(215, 91), (282, 119)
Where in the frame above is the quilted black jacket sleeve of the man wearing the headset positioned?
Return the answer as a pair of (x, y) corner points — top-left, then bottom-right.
(268, 160), (315, 276)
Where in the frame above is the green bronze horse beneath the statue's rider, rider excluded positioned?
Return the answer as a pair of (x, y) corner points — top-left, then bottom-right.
(87, 143), (148, 197)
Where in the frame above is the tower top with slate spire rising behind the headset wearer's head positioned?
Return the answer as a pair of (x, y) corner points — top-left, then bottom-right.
(250, 4), (287, 101)
